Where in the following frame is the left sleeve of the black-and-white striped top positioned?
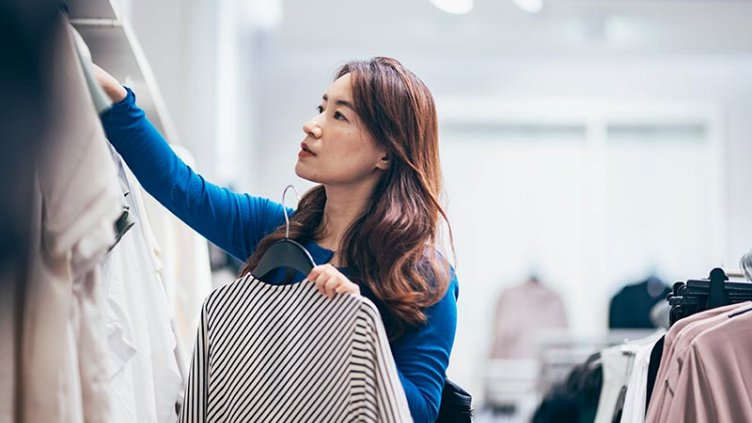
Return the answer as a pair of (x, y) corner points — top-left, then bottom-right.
(180, 301), (209, 423)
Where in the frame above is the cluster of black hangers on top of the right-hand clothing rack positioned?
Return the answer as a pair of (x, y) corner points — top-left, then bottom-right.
(667, 268), (752, 325)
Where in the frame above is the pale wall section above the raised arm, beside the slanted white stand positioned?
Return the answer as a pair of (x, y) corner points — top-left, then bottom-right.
(121, 0), (217, 176)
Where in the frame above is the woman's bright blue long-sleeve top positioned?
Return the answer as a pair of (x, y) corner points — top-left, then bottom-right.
(102, 89), (459, 423)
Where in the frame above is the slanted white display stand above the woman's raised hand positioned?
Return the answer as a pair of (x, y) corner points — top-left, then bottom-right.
(63, 0), (180, 144)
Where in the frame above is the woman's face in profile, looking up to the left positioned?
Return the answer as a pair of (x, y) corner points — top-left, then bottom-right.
(295, 74), (388, 189)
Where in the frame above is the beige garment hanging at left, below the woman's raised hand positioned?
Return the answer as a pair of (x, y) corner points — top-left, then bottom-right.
(20, 16), (121, 422)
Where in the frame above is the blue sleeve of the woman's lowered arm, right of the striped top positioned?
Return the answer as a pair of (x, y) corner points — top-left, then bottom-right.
(392, 270), (459, 423)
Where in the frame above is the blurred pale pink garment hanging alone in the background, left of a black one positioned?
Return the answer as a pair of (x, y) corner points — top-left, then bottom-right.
(491, 280), (567, 359)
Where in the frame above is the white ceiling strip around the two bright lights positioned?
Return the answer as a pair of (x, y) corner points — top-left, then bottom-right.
(267, 0), (752, 55)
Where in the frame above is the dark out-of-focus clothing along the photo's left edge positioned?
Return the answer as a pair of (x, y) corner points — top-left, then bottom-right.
(0, 0), (57, 422)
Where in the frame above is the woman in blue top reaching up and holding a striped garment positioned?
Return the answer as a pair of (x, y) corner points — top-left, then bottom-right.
(97, 57), (458, 422)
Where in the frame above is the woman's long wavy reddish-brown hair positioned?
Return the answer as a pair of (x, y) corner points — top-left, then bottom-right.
(243, 57), (451, 338)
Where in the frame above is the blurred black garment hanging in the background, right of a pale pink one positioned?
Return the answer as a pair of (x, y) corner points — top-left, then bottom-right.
(608, 278), (671, 329)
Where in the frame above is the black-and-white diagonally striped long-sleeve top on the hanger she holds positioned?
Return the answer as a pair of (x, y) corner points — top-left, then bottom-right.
(180, 275), (412, 423)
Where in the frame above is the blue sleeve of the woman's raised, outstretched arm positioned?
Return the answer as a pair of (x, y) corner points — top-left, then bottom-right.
(102, 89), (284, 260)
